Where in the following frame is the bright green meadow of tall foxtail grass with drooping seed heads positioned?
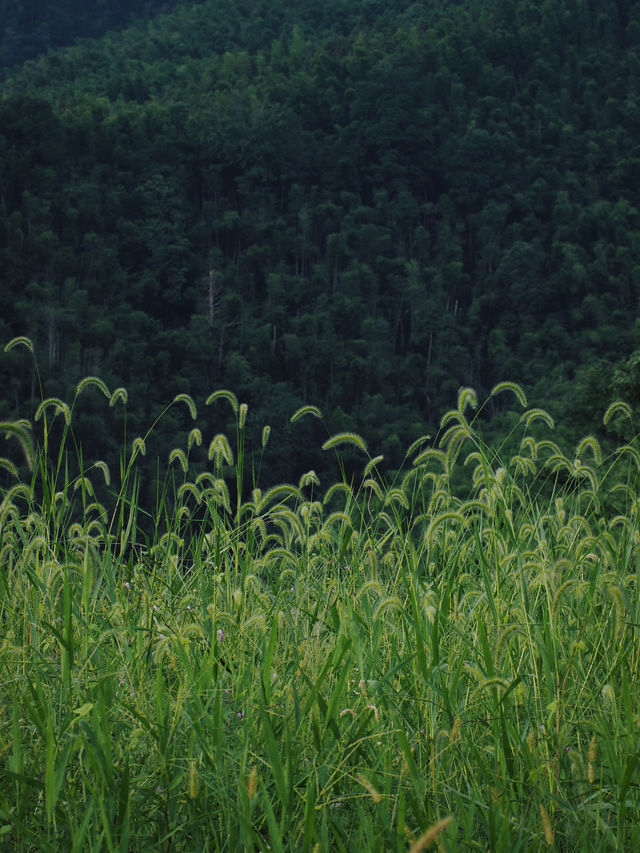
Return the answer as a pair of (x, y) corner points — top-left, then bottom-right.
(0, 338), (640, 853)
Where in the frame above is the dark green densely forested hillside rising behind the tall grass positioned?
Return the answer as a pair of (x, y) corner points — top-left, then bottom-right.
(0, 0), (640, 492)
